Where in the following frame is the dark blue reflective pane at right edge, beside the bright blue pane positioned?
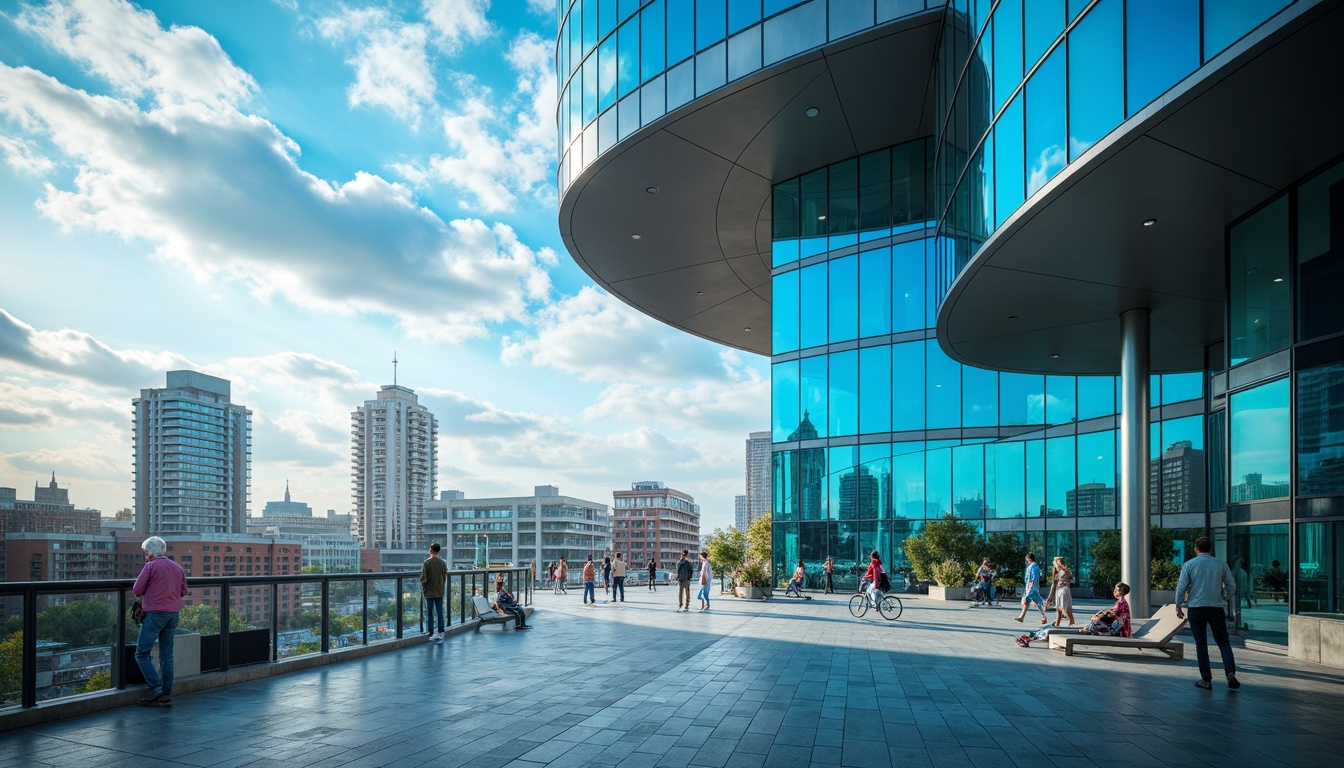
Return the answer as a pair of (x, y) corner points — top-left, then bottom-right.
(1297, 362), (1344, 495)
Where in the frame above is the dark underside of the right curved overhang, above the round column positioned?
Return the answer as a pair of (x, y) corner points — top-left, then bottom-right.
(938, 3), (1344, 375)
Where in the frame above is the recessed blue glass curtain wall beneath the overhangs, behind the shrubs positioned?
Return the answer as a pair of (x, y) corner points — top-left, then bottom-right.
(771, 140), (1207, 588)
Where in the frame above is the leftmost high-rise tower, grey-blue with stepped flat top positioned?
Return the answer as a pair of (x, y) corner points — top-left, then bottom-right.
(133, 371), (251, 537)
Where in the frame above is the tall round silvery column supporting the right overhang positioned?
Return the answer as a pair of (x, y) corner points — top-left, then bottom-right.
(1120, 308), (1152, 617)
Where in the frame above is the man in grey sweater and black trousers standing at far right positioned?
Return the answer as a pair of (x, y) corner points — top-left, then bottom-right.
(1176, 537), (1242, 690)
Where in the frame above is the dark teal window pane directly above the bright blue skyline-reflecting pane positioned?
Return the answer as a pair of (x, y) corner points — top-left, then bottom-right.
(1228, 195), (1290, 365)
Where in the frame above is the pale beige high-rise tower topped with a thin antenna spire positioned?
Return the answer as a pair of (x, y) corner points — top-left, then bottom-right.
(351, 385), (438, 550)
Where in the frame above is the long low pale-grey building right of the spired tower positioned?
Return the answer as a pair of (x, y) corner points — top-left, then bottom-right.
(422, 486), (612, 573)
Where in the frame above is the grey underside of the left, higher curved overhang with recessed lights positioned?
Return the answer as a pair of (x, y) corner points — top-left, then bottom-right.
(559, 9), (942, 355)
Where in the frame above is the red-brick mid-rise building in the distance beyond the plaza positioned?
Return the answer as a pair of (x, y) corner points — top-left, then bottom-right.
(612, 480), (700, 570)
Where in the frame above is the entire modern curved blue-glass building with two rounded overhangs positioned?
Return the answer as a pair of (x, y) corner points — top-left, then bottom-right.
(556, 0), (1344, 663)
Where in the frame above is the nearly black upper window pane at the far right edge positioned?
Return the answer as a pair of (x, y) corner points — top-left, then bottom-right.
(1297, 164), (1344, 340)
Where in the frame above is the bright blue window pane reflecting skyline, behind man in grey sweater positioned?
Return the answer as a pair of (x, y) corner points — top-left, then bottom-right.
(1228, 379), (1292, 502)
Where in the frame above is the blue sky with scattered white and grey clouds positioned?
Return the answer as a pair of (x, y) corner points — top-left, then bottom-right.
(0, 0), (770, 533)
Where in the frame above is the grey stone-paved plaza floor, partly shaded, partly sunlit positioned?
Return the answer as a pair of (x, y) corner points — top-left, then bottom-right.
(0, 588), (1344, 768)
